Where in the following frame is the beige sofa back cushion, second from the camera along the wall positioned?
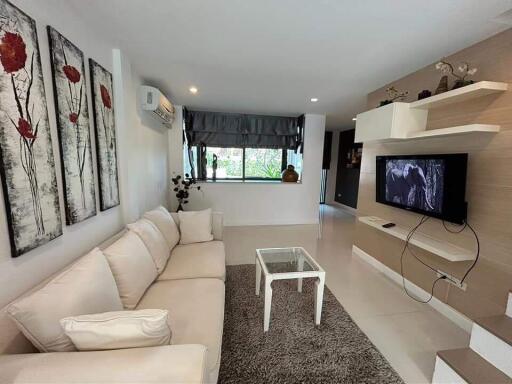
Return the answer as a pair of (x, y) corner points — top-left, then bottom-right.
(102, 231), (158, 312)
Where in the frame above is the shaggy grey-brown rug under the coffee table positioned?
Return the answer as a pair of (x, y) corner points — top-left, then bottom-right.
(219, 265), (403, 384)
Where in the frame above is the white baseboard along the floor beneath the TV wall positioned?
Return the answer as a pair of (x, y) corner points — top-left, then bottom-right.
(352, 245), (473, 333)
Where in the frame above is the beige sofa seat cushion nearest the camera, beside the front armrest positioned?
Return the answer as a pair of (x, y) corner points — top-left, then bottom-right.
(137, 279), (224, 374)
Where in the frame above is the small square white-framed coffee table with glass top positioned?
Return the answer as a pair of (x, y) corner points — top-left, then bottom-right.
(256, 247), (325, 332)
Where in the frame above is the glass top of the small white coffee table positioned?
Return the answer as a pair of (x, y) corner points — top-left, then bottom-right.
(257, 247), (320, 274)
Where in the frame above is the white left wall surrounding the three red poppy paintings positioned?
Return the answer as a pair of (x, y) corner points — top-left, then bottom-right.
(0, 0), (168, 307)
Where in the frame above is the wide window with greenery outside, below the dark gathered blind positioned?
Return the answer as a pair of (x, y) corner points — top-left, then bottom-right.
(183, 144), (302, 180)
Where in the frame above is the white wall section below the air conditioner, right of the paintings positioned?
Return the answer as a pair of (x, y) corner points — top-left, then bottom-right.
(113, 49), (169, 222)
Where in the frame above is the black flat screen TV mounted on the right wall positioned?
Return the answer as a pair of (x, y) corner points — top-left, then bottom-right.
(376, 153), (468, 224)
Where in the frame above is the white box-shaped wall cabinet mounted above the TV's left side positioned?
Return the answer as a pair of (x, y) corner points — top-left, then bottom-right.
(355, 103), (428, 143)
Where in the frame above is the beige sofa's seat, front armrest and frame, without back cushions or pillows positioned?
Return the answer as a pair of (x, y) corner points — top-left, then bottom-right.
(0, 213), (226, 383)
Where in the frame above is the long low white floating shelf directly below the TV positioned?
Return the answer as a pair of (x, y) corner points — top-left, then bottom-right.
(359, 216), (476, 261)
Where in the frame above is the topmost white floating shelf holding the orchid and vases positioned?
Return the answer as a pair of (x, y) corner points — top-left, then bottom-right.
(409, 81), (508, 109)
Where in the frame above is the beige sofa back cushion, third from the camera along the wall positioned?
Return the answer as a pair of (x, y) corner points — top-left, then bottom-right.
(127, 219), (171, 273)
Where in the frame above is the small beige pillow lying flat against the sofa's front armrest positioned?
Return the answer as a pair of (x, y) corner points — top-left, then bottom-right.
(60, 309), (171, 351)
